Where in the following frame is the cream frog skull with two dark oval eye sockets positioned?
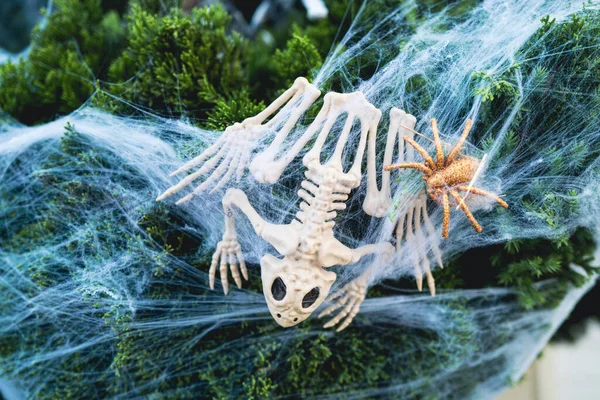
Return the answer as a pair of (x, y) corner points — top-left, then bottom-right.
(260, 254), (336, 328)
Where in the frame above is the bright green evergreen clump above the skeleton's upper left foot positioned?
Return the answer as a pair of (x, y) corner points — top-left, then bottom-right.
(109, 5), (252, 117)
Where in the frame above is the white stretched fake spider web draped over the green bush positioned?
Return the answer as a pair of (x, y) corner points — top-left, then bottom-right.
(0, 0), (600, 398)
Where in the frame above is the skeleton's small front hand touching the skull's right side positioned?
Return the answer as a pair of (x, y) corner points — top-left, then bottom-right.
(319, 276), (367, 332)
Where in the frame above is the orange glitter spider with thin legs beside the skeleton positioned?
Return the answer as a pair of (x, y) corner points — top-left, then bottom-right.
(384, 119), (508, 238)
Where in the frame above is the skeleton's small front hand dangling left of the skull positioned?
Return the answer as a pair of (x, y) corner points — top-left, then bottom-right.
(208, 237), (248, 294)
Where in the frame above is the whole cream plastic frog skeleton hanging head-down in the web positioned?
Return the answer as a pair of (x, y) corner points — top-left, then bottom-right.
(157, 78), (508, 331)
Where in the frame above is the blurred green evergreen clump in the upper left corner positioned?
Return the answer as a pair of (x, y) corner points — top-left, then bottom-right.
(0, 0), (124, 124)
